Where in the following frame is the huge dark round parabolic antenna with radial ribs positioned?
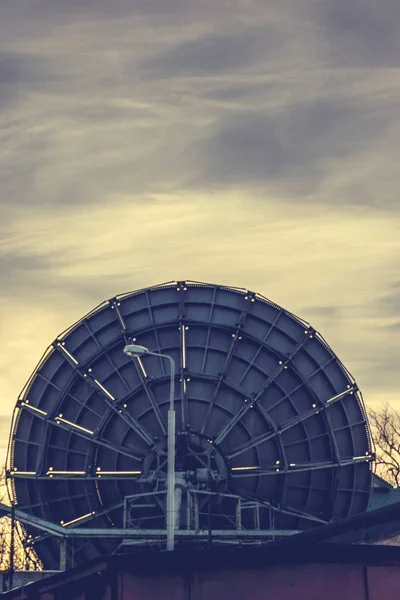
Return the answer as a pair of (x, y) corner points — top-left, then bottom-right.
(8, 281), (372, 568)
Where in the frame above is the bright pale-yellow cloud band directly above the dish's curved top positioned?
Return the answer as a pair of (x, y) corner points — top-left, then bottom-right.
(0, 192), (400, 406)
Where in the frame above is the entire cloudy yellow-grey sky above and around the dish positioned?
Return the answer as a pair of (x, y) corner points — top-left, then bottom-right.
(0, 0), (400, 462)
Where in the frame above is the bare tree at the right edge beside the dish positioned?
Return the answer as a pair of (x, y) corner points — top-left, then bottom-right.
(368, 404), (400, 487)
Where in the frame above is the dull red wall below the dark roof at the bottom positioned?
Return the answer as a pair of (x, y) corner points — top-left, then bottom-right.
(119, 564), (400, 600)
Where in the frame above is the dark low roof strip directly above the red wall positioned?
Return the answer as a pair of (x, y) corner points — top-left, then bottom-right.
(1, 542), (400, 599)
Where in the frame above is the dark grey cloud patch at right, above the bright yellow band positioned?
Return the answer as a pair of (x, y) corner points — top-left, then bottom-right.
(193, 99), (396, 204)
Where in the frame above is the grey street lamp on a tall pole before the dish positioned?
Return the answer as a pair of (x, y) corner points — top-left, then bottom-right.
(124, 344), (176, 550)
